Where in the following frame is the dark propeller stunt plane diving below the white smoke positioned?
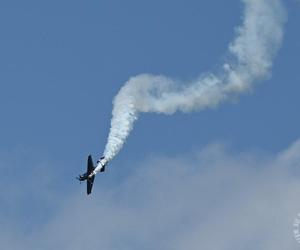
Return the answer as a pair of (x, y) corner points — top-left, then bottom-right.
(76, 155), (106, 195)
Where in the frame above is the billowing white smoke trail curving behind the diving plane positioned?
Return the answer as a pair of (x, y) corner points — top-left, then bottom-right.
(104, 0), (285, 161)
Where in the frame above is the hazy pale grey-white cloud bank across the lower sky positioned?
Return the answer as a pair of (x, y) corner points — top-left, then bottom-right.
(0, 141), (300, 250)
